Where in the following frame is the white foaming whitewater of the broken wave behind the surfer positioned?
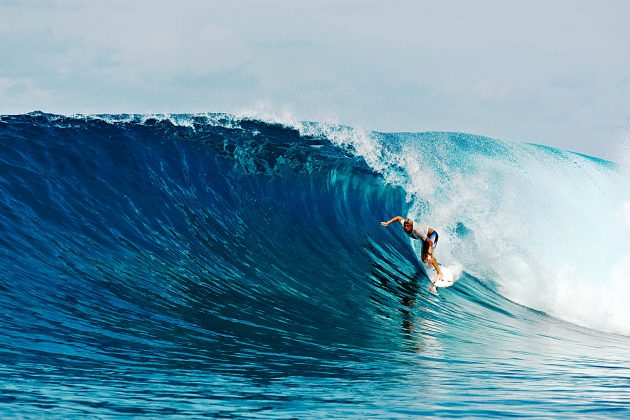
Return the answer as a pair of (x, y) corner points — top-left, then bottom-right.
(328, 130), (630, 335)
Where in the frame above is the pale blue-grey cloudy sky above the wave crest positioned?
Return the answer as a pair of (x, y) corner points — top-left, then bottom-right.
(0, 0), (630, 161)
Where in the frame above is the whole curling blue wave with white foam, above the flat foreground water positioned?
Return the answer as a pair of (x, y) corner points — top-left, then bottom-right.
(0, 113), (630, 414)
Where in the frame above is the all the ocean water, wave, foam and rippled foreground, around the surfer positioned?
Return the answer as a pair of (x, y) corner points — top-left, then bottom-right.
(0, 113), (630, 417)
